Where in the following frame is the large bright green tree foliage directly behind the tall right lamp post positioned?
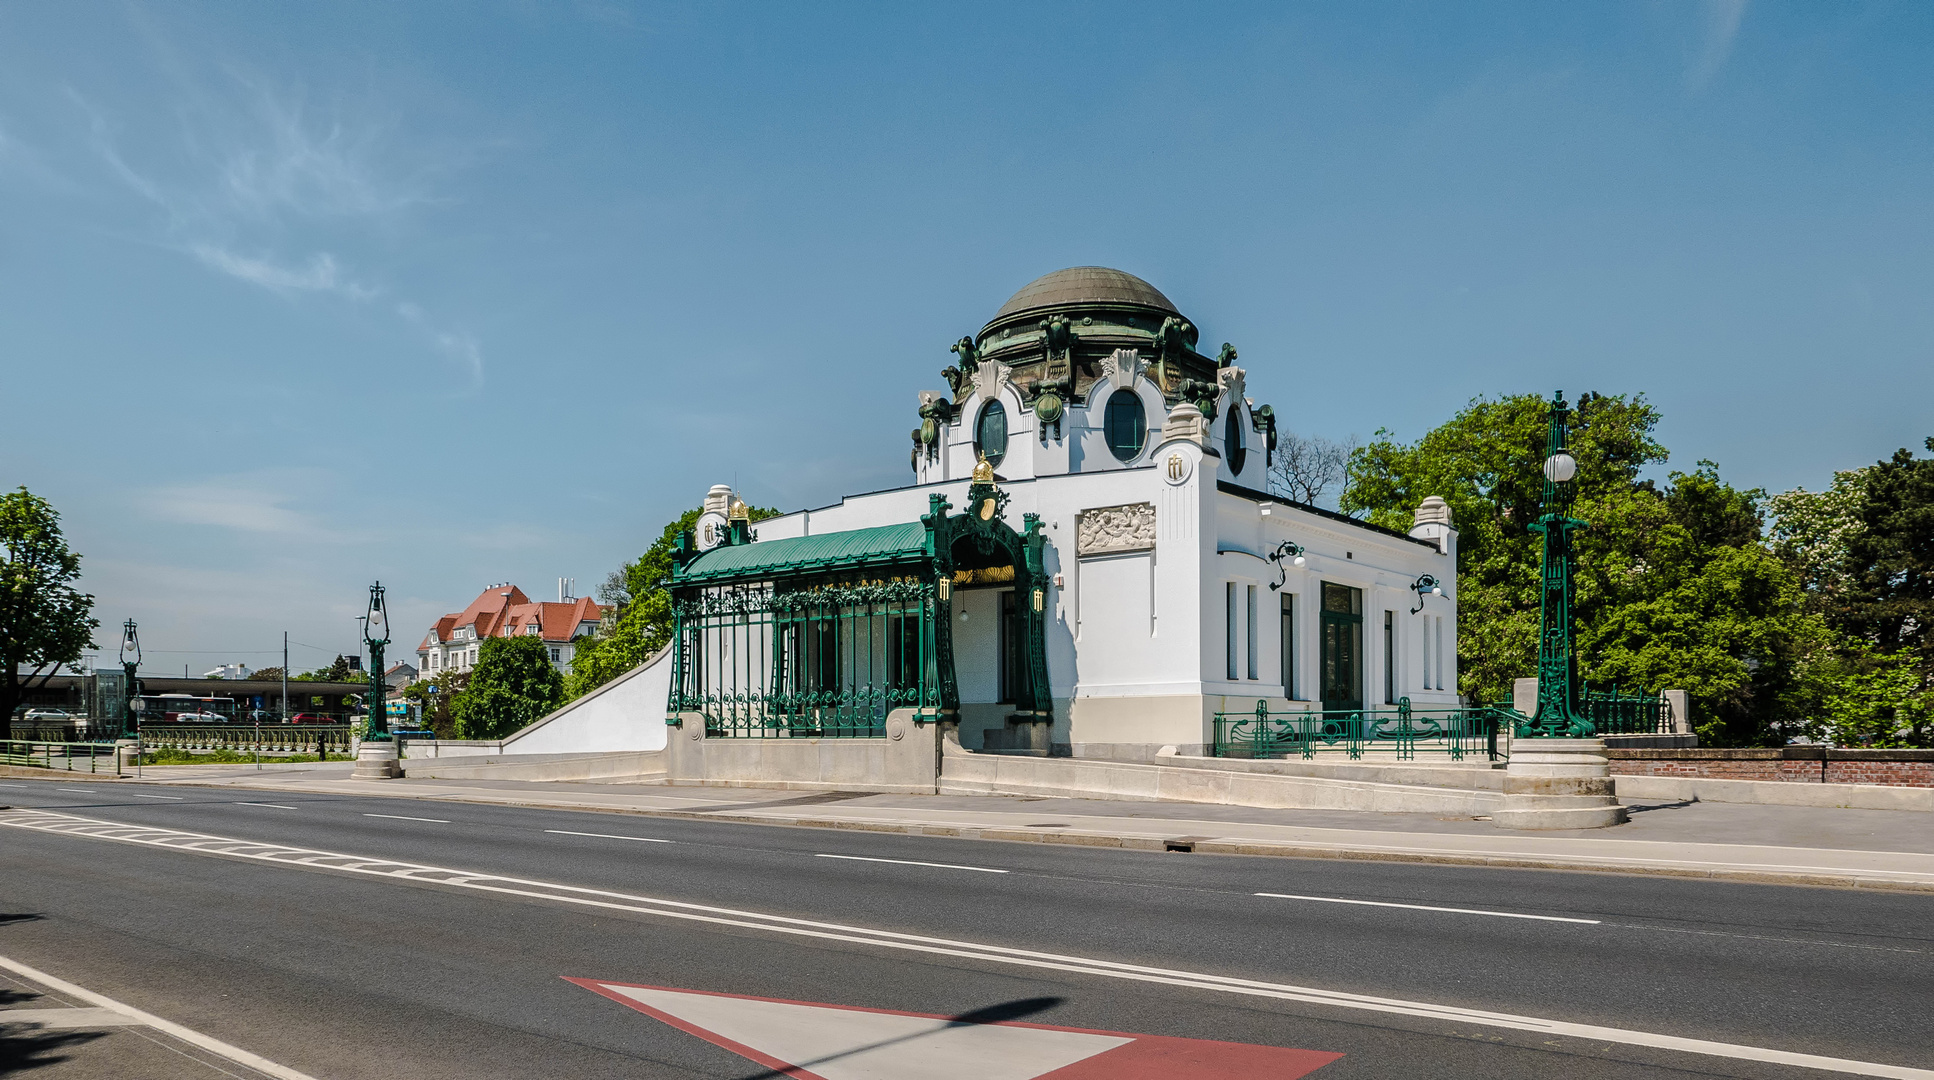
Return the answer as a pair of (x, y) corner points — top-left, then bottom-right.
(1342, 393), (1822, 745)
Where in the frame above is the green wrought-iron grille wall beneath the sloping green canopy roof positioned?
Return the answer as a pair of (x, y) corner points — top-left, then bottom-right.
(669, 579), (940, 739)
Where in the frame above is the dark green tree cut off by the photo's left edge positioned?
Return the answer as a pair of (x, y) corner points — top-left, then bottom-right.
(0, 488), (101, 737)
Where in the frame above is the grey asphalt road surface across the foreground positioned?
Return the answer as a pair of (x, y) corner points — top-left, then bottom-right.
(0, 782), (1934, 1080)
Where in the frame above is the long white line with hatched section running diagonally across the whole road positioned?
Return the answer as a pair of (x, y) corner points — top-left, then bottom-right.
(0, 809), (1934, 1080)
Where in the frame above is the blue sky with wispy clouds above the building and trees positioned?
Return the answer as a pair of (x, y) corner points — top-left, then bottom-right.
(0, 2), (1934, 672)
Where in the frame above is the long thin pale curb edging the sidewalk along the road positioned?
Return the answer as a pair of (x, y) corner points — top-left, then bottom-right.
(87, 780), (1934, 894)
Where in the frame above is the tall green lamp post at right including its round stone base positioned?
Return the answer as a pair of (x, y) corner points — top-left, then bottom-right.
(1491, 391), (1625, 828)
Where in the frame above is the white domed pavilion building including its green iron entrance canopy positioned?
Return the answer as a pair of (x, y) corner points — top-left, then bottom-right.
(669, 267), (1458, 759)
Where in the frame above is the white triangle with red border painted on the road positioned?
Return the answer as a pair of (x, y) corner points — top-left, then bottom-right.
(571, 979), (1342, 1080)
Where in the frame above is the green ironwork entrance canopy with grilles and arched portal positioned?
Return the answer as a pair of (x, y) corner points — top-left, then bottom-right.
(667, 483), (1054, 737)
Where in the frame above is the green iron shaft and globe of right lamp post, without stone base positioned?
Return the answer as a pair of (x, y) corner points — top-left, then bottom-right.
(1518, 391), (1596, 739)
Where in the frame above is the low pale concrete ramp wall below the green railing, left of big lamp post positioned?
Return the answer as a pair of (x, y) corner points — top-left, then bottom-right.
(940, 737), (1503, 817)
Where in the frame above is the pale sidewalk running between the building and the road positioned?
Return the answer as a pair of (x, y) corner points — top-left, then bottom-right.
(15, 765), (1934, 892)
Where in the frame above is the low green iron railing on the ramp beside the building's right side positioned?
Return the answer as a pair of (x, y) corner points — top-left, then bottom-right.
(1215, 697), (1516, 761)
